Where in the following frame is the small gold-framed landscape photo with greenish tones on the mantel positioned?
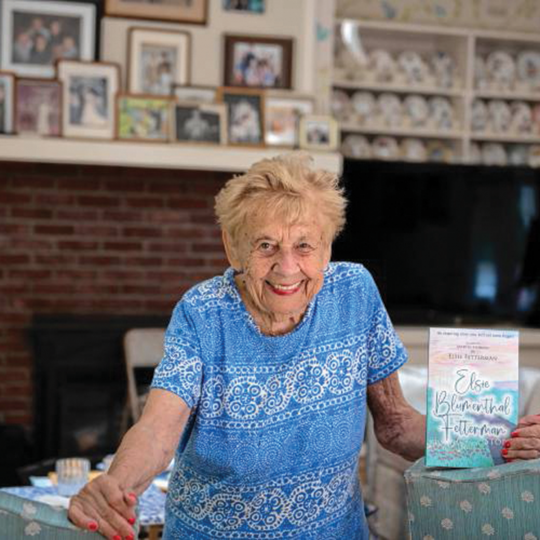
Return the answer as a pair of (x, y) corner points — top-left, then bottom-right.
(116, 94), (173, 142)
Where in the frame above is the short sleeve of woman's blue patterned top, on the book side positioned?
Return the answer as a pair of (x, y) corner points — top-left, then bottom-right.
(367, 273), (408, 384)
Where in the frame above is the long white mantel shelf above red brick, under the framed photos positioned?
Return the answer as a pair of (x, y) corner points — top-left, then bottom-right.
(0, 136), (343, 173)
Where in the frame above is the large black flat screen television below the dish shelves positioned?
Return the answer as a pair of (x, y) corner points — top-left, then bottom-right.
(332, 160), (540, 327)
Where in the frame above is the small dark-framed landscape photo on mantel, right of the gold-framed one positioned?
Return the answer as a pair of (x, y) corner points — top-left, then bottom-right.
(173, 103), (227, 144)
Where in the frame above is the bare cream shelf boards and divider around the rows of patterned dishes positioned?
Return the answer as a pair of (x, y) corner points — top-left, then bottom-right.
(332, 19), (540, 163)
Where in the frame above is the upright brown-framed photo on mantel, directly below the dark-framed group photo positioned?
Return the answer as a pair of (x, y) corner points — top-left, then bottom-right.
(218, 87), (264, 146)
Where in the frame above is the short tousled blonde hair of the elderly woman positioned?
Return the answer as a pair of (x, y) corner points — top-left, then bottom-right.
(215, 152), (347, 244)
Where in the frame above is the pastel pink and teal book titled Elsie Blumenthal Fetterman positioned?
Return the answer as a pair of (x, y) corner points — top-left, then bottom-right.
(426, 328), (519, 468)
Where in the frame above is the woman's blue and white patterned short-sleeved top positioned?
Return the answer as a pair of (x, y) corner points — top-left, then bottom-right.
(152, 263), (407, 540)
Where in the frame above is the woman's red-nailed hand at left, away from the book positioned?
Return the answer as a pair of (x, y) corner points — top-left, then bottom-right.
(68, 473), (137, 540)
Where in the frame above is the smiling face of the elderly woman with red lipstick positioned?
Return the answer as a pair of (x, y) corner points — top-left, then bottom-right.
(225, 211), (332, 330)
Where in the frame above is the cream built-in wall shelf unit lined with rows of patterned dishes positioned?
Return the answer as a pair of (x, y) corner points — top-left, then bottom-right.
(332, 19), (540, 165)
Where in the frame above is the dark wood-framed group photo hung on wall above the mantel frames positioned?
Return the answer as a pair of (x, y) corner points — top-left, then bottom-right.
(223, 35), (293, 89)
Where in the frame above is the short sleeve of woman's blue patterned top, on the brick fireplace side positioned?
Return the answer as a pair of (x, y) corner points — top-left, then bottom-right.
(151, 301), (202, 408)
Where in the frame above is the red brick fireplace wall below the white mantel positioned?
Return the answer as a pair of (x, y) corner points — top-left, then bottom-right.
(0, 163), (230, 425)
